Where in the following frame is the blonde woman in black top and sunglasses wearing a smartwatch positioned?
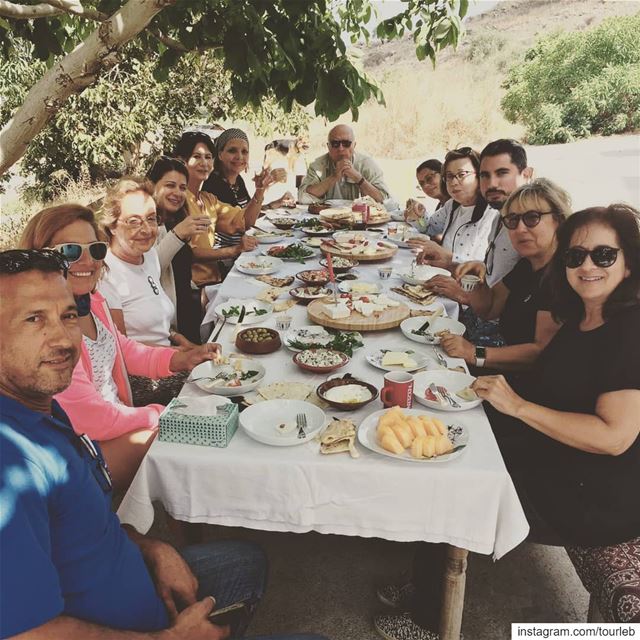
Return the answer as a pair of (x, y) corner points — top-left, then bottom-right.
(434, 178), (571, 370)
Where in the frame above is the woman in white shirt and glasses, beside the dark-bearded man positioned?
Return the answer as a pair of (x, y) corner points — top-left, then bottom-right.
(409, 147), (499, 270)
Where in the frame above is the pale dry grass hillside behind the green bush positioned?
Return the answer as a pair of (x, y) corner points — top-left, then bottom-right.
(304, 0), (640, 160)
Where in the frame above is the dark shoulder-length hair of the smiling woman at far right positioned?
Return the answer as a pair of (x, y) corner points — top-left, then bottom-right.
(549, 204), (640, 323)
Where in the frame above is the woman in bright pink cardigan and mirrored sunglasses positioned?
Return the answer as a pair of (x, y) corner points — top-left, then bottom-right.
(20, 204), (219, 489)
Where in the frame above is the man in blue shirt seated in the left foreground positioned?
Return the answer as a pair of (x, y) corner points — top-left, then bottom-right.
(0, 250), (328, 640)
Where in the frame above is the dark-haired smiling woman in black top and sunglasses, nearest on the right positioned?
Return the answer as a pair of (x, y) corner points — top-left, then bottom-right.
(473, 204), (640, 623)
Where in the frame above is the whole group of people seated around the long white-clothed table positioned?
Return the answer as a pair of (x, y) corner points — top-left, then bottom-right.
(0, 120), (640, 640)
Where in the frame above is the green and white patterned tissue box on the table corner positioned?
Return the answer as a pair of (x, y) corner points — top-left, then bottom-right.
(158, 397), (238, 447)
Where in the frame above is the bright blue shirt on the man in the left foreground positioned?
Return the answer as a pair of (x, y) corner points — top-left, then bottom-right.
(0, 396), (168, 638)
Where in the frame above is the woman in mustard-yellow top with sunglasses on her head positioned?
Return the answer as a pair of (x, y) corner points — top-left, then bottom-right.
(174, 131), (258, 287)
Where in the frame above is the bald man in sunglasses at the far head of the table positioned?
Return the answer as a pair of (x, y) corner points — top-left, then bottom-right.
(298, 124), (389, 204)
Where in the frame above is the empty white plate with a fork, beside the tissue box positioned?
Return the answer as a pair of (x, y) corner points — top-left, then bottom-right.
(240, 400), (327, 447)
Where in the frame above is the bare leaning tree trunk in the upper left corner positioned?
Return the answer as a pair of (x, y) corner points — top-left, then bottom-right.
(0, 0), (175, 175)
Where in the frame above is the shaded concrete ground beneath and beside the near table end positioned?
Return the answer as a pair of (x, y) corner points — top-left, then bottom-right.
(151, 514), (588, 640)
